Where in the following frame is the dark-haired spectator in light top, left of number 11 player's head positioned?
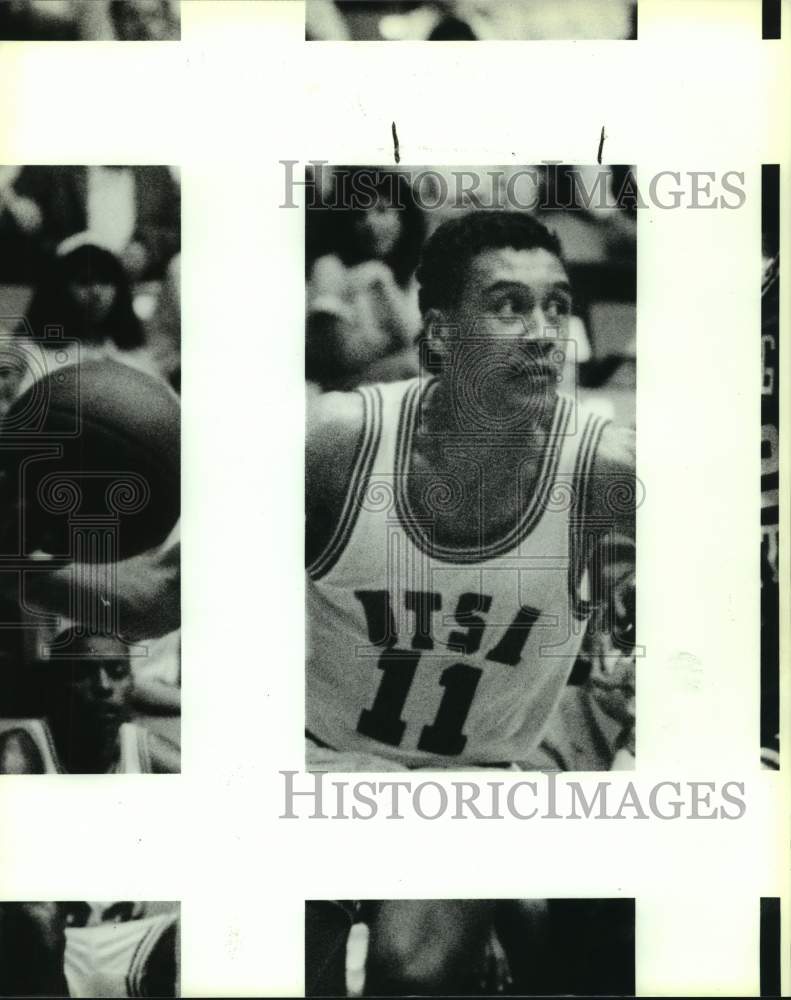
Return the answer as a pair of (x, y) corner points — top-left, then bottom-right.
(306, 167), (425, 389)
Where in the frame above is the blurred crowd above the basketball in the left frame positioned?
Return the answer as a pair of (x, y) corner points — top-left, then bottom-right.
(0, 166), (181, 392)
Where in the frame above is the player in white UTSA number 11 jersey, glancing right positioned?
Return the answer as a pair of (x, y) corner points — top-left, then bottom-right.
(306, 212), (634, 770)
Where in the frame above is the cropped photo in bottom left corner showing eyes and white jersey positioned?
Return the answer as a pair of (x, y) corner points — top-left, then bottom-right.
(0, 901), (181, 998)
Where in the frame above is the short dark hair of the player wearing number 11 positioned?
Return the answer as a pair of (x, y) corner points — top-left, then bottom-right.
(416, 209), (563, 315)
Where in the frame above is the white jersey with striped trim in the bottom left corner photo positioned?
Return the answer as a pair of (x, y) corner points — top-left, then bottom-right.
(63, 913), (177, 997)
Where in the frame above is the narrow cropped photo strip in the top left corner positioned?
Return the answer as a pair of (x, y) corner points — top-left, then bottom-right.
(0, 0), (181, 42)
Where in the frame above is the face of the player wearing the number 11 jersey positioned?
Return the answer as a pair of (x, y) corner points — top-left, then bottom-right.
(447, 247), (572, 395)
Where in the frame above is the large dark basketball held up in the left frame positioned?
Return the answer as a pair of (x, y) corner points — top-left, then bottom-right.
(0, 360), (180, 562)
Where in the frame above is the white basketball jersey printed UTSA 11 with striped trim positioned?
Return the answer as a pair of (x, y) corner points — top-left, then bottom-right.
(306, 379), (607, 767)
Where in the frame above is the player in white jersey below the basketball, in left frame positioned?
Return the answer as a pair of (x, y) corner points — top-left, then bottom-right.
(0, 636), (179, 774)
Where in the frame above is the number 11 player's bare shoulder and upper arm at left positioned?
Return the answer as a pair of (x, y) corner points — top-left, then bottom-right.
(305, 392), (364, 564)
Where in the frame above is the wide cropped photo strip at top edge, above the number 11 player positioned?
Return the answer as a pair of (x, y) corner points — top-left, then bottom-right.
(305, 0), (637, 42)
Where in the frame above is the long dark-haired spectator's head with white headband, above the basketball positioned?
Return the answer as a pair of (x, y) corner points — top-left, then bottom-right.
(19, 233), (158, 375)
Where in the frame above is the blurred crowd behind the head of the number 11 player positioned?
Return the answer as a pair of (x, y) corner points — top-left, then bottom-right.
(306, 166), (636, 424)
